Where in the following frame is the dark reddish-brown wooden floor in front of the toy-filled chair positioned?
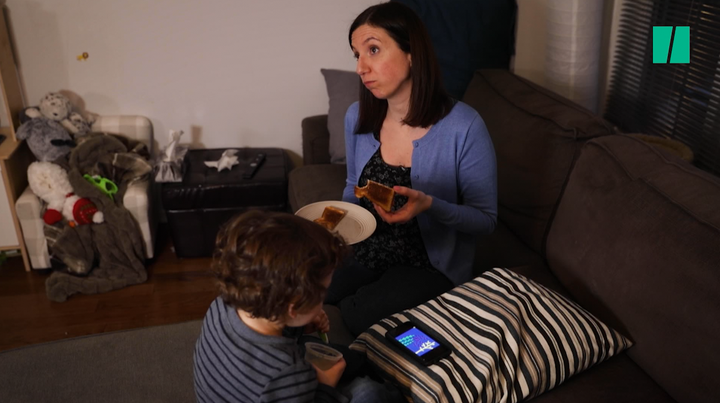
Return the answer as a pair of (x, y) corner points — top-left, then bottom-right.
(0, 227), (217, 350)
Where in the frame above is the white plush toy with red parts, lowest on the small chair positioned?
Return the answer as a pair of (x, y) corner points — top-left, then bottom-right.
(28, 162), (105, 227)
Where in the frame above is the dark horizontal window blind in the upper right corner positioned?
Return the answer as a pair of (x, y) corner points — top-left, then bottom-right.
(605, 0), (720, 176)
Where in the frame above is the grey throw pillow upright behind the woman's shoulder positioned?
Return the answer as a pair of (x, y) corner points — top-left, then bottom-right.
(320, 69), (360, 164)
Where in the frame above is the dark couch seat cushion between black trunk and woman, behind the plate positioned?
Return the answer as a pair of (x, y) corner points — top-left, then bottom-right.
(288, 164), (347, 212)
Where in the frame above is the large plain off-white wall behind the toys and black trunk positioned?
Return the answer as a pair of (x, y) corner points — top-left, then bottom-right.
(7, 0), (380, 166)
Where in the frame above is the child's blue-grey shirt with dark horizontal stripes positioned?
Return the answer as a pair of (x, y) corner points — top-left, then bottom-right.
(195, 297), (348, 403)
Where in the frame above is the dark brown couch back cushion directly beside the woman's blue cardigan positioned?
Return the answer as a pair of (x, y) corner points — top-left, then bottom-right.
(463, 70), (613, 254)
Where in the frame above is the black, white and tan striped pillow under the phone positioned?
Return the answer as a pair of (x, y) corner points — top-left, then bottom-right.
(350, 269), (632, 403)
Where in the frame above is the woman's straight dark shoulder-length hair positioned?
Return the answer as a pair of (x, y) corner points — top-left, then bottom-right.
(348, 2), (453, 133)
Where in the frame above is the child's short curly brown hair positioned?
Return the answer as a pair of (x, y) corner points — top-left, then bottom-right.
(212, 210), (348, 320)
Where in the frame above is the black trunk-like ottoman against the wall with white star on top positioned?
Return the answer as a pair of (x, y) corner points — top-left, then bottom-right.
(162, 148), (290, 257)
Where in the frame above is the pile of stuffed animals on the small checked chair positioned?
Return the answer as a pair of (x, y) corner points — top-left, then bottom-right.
(17, 92), (104, 226)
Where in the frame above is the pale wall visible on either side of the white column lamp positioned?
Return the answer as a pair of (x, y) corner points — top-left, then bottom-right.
(513, 0), (625, 112)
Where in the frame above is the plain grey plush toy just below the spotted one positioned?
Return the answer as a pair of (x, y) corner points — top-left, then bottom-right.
(17, 117), (75, 162)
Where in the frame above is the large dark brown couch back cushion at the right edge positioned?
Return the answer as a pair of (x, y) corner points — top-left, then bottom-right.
(547, 136), (720, 402)
